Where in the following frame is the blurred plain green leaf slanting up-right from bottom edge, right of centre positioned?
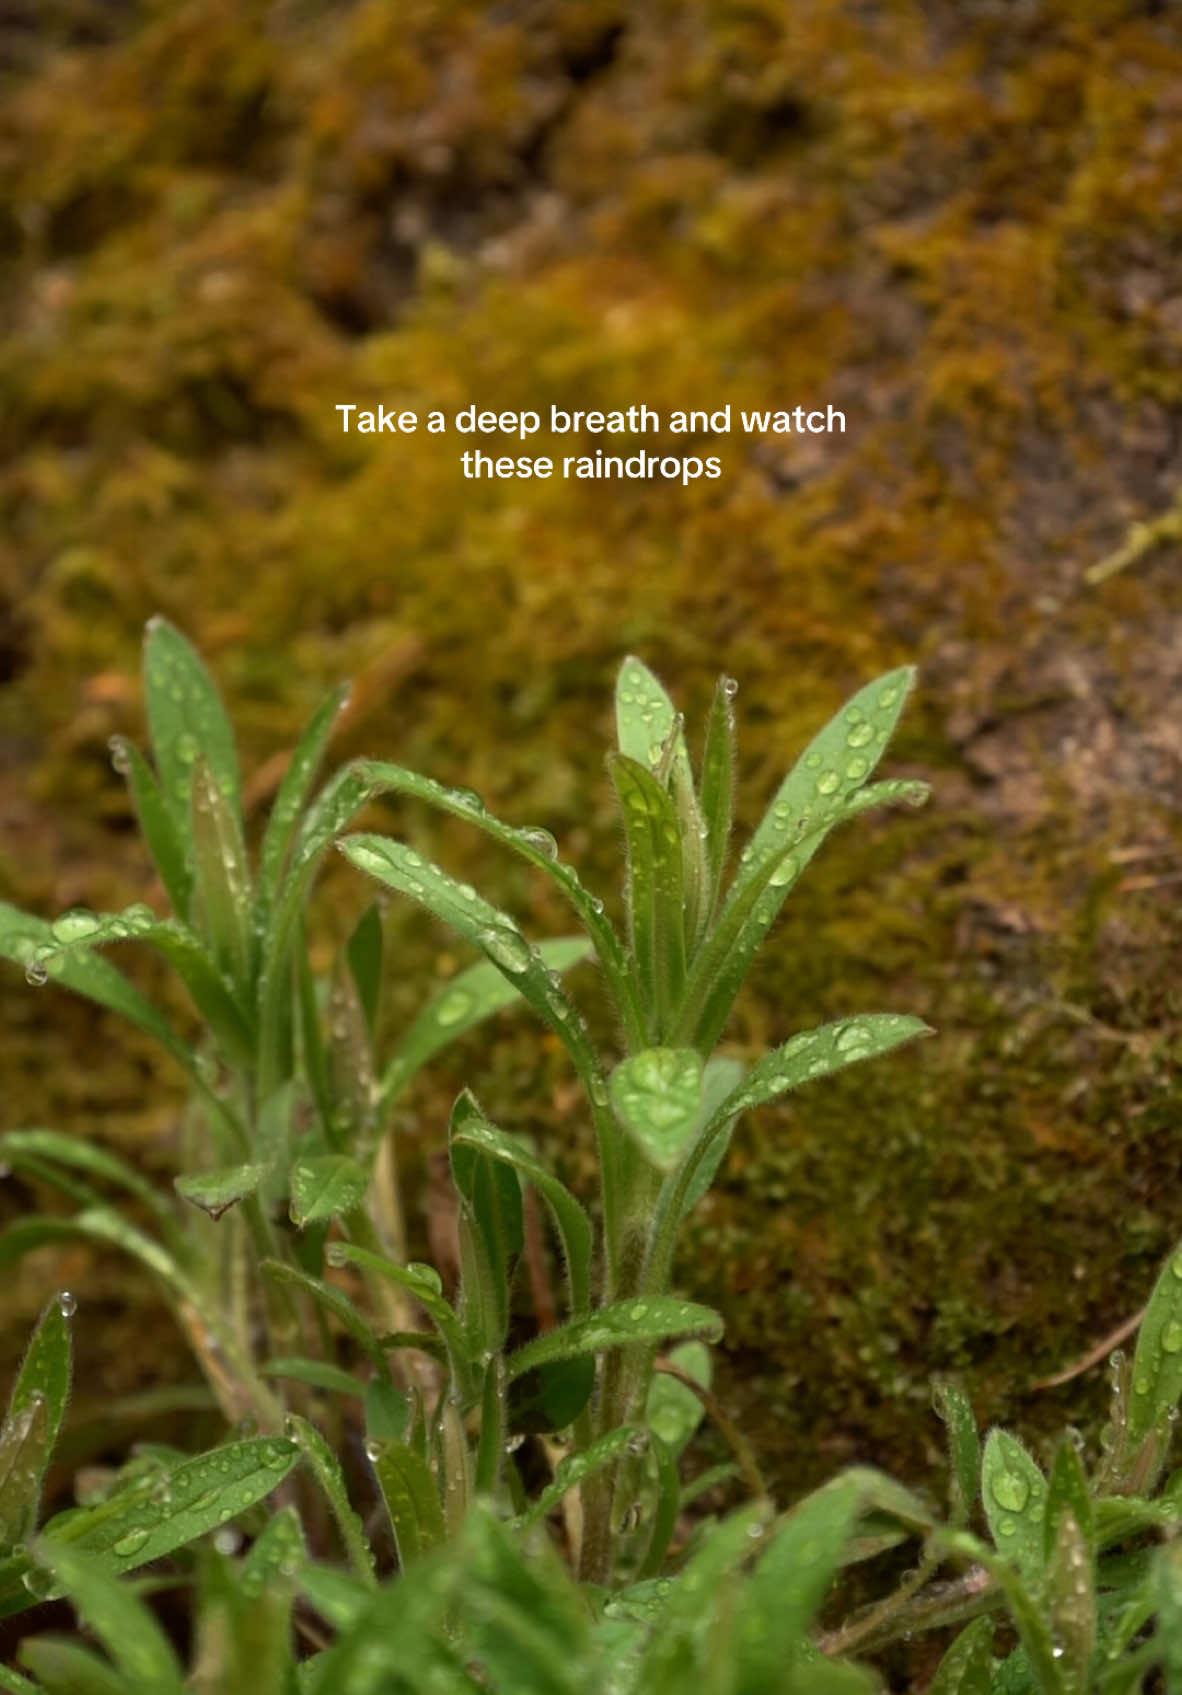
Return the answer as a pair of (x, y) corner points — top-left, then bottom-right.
(734, 1478), (860, 1695)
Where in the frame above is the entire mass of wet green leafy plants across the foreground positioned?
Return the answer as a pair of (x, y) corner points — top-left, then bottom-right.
(0, 622), (1182, 1695)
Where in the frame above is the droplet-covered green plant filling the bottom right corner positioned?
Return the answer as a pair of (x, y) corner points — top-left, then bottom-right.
(810, 1244), (1182, 1695)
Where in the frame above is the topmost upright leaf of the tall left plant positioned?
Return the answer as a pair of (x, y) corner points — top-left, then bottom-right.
(144, 617), (243, 841)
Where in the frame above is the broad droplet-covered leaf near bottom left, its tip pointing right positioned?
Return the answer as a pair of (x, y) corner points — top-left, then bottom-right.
(42, 1436), (300, 1575)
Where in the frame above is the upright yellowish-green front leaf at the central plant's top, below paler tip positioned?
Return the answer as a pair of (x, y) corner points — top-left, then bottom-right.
(607, 754), (685, 1034)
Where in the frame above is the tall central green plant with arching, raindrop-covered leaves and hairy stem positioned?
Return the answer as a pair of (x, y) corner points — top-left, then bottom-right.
(329, 659), (926, 1581)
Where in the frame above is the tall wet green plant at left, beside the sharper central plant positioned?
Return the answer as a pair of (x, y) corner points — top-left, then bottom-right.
(0, 619), (585, 1429)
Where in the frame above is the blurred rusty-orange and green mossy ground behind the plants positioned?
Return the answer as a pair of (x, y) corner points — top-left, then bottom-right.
(0, 0), (1182, 1511)
